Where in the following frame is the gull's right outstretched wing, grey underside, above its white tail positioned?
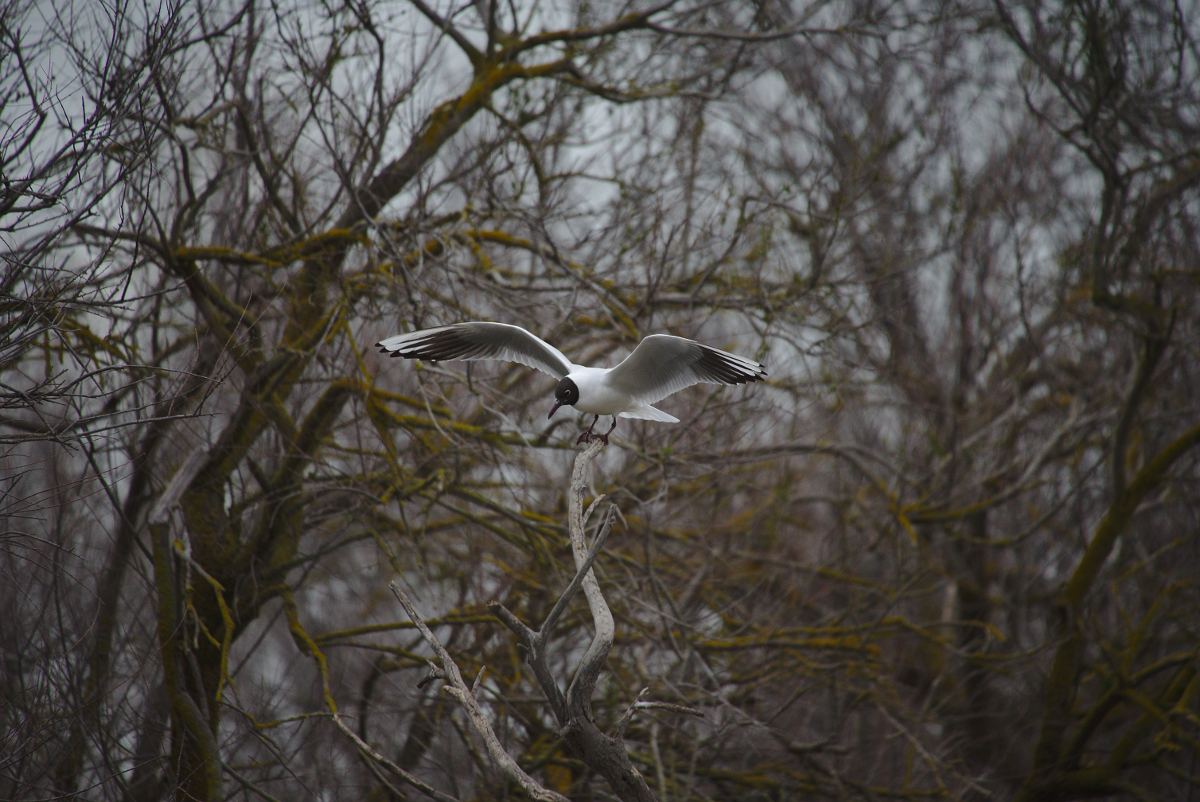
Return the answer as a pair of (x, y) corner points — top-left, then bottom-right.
(607, 334), (767, 405)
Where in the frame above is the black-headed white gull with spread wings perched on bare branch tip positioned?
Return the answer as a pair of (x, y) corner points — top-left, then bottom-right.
(376, 321), (767, 444)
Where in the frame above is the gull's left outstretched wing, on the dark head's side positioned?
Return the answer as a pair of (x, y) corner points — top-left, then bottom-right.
(376, 321), (574, 378)
